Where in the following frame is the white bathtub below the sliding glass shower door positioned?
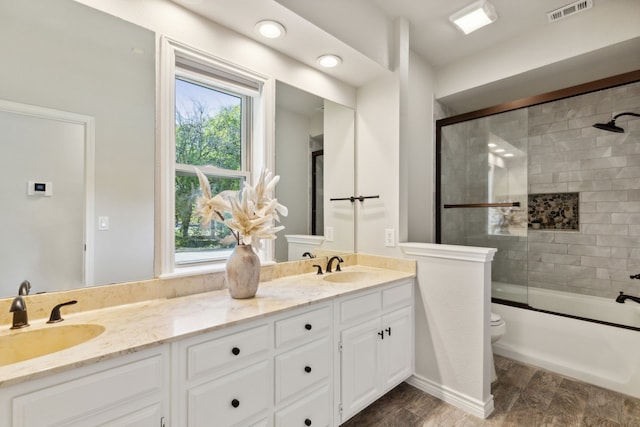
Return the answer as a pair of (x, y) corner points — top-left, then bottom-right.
(491, 284), (640, 398)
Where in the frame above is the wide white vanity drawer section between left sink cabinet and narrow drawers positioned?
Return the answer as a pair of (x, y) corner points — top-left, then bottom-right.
(172, 321), (273, 427)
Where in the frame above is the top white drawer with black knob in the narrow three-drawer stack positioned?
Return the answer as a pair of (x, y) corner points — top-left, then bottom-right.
(275, 306), (331, 348)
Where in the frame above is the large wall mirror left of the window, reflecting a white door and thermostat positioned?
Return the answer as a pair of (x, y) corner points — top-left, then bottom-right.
(0, 0), (155, 297)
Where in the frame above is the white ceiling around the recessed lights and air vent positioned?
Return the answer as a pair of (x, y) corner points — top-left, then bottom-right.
(172, 0), (640, 112)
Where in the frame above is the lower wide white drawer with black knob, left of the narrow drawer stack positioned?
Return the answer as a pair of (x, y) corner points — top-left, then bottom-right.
(187, 361), (271, 427)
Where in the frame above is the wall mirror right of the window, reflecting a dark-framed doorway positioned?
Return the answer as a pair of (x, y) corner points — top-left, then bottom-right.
(275, 82), (355, 262)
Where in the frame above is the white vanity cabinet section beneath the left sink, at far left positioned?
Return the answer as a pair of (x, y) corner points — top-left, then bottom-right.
(0, 346), (169, 427)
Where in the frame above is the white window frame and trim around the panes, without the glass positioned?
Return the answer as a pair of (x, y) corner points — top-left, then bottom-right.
(155, 36), (275, 278)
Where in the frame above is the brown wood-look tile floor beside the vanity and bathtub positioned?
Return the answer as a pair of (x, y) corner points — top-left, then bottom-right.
(342, 356), (640, 427)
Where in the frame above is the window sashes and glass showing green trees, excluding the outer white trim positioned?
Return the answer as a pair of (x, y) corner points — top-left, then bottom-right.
(174, 75), (251, 265)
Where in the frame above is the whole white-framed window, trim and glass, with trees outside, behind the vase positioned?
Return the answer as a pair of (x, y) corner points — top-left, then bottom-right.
(156, 39), (273, 276)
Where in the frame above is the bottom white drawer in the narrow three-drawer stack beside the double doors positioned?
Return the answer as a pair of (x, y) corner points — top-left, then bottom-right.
(276, 385), (331, 427)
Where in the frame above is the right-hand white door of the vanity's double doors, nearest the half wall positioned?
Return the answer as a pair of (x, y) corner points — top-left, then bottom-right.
(380, 307), (413, 391)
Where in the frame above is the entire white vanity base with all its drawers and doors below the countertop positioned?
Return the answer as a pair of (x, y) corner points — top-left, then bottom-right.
(0, 279), (414, 427)
